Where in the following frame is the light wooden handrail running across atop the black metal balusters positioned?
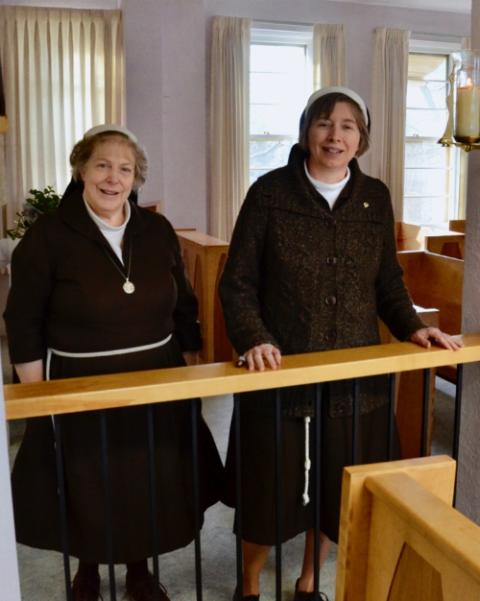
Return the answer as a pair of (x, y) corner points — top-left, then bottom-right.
(4, 334), (480, 420)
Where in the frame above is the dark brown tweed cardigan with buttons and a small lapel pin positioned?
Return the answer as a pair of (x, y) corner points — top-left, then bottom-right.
(220, 145), (424, 414)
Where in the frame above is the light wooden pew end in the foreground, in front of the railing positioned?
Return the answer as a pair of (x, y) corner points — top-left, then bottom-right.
(335, 456), (480, 601)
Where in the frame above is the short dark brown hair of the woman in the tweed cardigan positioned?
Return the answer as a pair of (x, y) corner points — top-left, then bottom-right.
(298, 92), (370, 156)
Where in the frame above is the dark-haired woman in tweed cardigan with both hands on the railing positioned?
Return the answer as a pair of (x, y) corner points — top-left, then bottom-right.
(220, 87), (456, 601)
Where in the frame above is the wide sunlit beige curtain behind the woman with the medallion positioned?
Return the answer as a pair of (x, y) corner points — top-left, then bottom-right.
(0, 6), (125, 232)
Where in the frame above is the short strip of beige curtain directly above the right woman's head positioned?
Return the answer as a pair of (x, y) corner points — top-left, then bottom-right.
(313, 23), (346, 90)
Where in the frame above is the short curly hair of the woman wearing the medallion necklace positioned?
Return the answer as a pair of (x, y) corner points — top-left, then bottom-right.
(70, 131), (148, 190)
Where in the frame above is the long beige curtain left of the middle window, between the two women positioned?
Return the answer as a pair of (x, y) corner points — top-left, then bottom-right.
(209, 17), (250, 241)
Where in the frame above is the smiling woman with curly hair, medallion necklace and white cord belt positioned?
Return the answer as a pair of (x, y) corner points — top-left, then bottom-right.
(5, 125), (222, 601)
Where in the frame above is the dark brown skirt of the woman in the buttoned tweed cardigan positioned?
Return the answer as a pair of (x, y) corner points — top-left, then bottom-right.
(223, 390), (398, 545)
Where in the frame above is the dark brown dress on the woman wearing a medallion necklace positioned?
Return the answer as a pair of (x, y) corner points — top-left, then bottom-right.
(5, 191), (222, 563)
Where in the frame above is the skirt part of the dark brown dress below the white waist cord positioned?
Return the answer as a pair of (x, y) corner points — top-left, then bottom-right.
(12, 341), (223, 563)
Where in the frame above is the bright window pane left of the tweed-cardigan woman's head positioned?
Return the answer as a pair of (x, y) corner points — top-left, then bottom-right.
(249, 26), (313, 183)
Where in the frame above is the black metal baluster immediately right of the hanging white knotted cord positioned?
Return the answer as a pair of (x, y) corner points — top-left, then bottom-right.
(313, 384), (323, 599)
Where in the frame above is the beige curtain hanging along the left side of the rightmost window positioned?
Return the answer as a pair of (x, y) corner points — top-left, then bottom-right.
(371, 28), (410, 221)
